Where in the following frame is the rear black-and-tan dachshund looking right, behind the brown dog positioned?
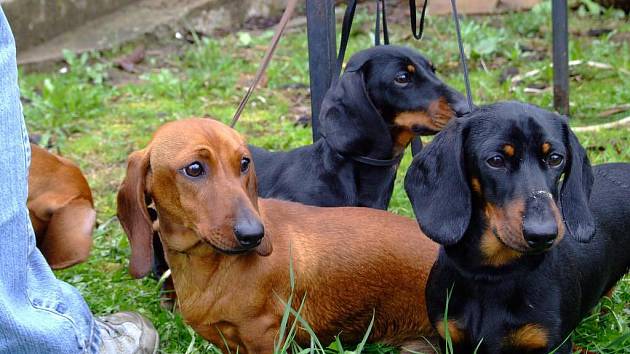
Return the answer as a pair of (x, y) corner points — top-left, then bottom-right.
(250, 45), (468, 209)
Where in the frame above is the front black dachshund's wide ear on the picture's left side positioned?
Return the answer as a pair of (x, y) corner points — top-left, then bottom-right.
(405, 121), (471, 245)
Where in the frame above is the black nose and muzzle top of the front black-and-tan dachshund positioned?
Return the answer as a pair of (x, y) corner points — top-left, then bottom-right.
(523, 193), (559, 251)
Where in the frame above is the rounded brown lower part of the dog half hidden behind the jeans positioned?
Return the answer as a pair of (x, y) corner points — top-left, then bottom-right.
(38, 199), (96, 269)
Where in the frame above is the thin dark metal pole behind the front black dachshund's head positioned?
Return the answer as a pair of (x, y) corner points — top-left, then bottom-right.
(551, 0), (569, 115)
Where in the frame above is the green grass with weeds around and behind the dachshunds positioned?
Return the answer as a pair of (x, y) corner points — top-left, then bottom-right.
(20, 1), (630, 353)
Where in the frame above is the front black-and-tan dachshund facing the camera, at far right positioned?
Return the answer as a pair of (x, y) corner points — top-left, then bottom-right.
(405, 102), (630, 353)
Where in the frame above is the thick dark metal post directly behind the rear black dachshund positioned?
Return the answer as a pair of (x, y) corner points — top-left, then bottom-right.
(306, 0), (338, 141)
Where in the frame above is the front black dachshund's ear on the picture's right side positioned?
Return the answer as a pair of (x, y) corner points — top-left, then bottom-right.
(560, 122), (595, 242)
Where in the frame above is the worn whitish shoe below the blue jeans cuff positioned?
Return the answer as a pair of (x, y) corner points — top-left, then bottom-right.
(95, 312), (160, 354)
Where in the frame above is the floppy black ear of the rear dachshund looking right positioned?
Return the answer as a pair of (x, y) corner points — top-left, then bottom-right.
(319, 70), (392, 158)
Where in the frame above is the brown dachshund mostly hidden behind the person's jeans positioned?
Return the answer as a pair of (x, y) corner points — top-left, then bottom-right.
(27, 144), (96, 269)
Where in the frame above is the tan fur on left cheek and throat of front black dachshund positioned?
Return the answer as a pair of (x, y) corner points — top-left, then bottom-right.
(480, 200), (527, 267)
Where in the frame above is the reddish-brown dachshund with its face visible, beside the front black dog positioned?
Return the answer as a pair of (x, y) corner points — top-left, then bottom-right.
(118, 119), (438, 354)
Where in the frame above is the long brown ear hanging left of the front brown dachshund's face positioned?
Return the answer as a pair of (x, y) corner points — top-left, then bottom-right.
(117, 148), (153, 278)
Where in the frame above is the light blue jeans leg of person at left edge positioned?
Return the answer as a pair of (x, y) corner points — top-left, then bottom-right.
(0, 8), (100, 354)
